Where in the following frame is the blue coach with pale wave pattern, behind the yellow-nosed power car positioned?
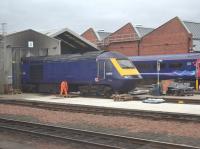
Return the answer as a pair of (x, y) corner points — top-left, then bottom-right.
(129, 53), (200, 80)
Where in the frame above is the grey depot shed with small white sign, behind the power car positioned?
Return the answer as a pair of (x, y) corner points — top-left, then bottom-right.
(0, 28), (99, 93)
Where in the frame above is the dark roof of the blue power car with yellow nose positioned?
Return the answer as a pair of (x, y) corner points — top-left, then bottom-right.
(22, 51), (127, 62)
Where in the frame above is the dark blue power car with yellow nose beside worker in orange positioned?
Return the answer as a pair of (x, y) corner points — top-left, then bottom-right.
(22, 51), (141, 95)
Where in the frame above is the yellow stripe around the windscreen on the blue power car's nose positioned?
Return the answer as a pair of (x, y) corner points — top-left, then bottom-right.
(110, 58), (139, 76)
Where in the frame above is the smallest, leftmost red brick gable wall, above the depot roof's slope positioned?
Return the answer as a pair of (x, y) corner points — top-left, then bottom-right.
(81, 28), (98, 44)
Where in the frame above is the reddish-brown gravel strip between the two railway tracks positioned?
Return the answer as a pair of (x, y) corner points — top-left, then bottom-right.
(0, 104), (200, 147)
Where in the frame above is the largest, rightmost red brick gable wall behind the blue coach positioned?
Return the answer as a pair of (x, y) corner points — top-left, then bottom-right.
(140, 17), (192, 55)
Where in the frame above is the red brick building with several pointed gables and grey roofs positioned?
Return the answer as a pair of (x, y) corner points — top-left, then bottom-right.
(82, 17), (200, 56)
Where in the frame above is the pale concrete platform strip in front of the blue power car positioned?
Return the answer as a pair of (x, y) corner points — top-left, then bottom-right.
(0, 94), (200, 115)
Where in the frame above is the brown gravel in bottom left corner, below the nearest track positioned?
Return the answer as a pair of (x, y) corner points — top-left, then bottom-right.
(0, 130), (78, 149)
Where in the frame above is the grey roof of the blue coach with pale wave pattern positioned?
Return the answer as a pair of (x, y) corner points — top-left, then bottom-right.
(129, 53), (200, 61)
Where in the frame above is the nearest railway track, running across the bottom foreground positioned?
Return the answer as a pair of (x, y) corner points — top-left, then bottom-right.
(0, 118), (200, 149)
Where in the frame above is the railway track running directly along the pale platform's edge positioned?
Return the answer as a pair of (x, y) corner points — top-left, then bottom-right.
(0, 99), (200, 122)
